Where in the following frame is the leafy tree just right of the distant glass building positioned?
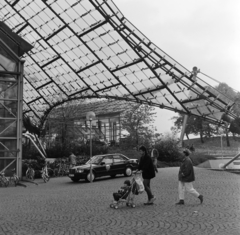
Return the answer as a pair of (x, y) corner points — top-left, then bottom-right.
(121, 104), (156, 149)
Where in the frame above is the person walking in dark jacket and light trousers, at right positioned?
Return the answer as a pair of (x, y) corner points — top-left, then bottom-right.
(176, 149), (203, 205)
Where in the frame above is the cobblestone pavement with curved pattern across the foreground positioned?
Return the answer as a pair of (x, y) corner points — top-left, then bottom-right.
(0, 168), (240, 235)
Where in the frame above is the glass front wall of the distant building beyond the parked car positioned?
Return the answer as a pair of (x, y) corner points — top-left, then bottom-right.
(45, 112), (121, 146)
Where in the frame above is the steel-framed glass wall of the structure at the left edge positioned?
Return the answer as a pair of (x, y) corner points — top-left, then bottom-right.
(0, 39), (23, 176)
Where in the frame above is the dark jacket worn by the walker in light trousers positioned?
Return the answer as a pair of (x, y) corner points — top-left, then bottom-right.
(178, 157), (195, 183)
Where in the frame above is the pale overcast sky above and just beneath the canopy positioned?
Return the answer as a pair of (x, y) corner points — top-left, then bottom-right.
(113, 0), (240, 134)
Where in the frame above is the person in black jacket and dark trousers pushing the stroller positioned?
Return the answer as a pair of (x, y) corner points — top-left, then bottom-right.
(138, 146), (156, 205)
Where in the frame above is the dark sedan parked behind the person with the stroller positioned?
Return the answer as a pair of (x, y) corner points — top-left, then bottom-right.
(68, 153), (138, 182)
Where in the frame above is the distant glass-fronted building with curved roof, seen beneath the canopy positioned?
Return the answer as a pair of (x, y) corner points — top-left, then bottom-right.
(46, 100), (138, 143)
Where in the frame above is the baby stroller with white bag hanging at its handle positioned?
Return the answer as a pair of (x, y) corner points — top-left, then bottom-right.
(110, 172), (144, 209)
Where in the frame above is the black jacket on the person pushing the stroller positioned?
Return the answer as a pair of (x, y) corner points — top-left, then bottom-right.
(138, 155), (155, 179)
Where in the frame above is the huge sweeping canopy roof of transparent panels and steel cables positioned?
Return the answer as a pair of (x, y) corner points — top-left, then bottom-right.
(0, 0), (235, 126)
